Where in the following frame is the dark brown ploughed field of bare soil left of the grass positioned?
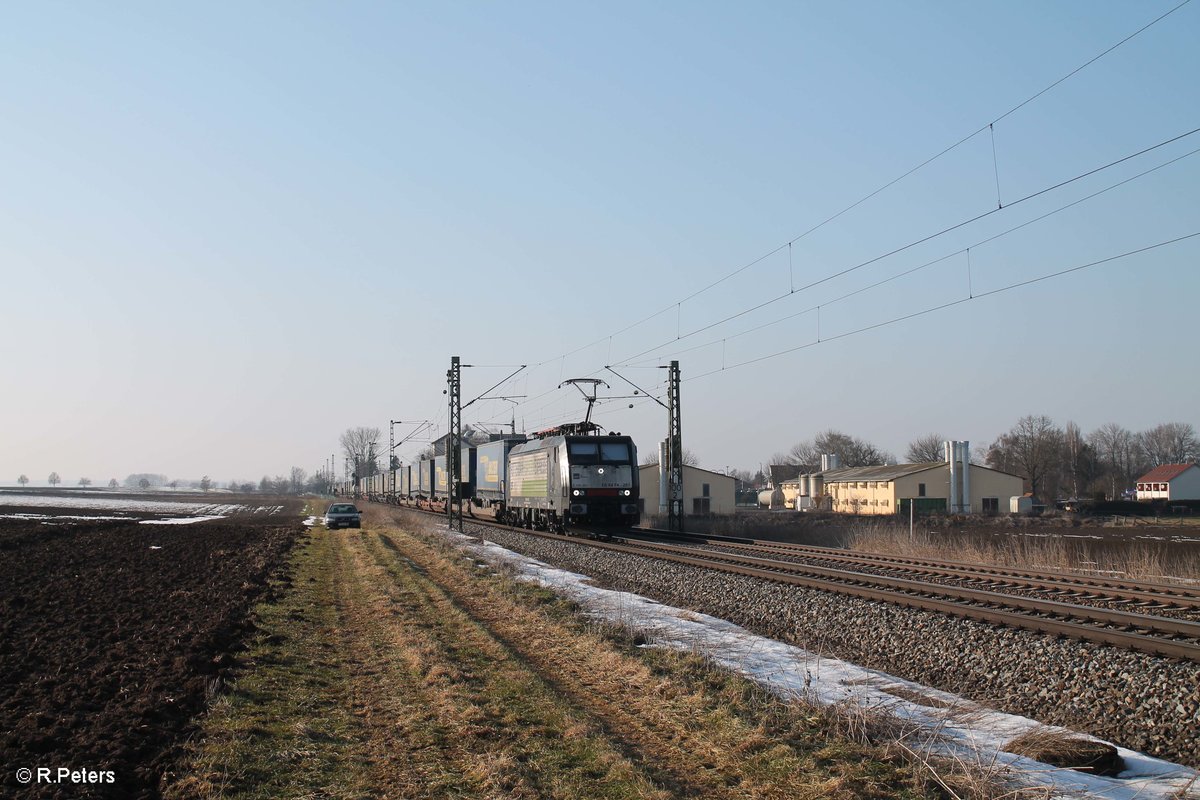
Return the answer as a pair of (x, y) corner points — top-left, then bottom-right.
(0, 503), (302, 799)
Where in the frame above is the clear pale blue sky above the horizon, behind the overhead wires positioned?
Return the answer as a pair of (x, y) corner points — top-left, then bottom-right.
(0, 0), (1200, 485)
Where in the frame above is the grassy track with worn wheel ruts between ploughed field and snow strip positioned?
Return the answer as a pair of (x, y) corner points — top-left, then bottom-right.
(167, 518), (917, 799)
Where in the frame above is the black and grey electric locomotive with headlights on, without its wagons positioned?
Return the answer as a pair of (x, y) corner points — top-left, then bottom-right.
(499, 423), (640, 531)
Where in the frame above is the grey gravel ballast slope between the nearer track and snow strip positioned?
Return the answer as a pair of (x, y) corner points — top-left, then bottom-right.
(472, 528), (1200, 768)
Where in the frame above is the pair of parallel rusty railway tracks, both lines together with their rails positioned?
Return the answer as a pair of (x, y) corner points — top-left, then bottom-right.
(374, 501), (1200, 662)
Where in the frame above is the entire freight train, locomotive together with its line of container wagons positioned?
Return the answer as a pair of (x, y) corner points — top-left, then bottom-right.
(336, 423), (641, 533)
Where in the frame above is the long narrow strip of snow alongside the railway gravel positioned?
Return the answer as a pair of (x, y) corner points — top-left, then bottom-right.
(443, 529), (1200, 800)
